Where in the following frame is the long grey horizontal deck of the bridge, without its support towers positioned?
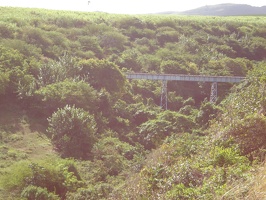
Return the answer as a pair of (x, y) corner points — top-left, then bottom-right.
(126, 73), (245, 83)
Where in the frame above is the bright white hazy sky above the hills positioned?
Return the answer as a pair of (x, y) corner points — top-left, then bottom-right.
(0, 0), (266, 14)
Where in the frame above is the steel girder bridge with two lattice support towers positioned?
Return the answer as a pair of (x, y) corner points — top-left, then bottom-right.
(126, 73), (245, 110)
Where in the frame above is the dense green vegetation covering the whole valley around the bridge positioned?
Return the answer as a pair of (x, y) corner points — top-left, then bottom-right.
(0, 7), (266, 200)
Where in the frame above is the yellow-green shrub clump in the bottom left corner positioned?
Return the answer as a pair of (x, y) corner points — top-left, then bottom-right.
(0, 158), (83, 200)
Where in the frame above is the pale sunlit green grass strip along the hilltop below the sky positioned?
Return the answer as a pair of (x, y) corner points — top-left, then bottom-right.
(0, 7), (266, 25)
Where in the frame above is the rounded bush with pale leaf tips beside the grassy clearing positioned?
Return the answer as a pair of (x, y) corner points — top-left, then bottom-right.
(47, 105), (96, 159)
